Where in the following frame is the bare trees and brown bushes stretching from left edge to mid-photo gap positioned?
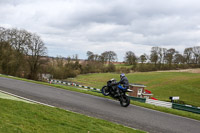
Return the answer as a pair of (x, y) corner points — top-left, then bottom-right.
(0, 27), (116, 80)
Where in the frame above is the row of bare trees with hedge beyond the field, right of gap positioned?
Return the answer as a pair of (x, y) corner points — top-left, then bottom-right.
(125, 46), (200, 71)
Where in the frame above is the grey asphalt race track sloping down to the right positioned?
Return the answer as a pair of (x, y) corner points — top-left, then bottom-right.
(0, 77), (200, 133)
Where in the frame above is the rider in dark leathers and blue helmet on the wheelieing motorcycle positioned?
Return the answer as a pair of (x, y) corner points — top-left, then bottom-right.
(116, 73), (129, 96)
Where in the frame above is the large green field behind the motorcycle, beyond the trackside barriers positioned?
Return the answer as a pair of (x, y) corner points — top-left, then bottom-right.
(70, 72), (200, 106)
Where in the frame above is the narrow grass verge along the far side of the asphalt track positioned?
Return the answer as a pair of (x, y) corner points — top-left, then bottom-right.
(0, 75), (200, 120)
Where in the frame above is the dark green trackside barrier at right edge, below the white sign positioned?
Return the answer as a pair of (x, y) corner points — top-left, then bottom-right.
(172, 103), (200, 114)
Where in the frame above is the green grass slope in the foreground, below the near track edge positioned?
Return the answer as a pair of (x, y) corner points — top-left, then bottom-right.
(0, 98), (142, 133)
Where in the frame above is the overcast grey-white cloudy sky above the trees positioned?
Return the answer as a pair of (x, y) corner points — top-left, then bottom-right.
(0, 0), (200, 61)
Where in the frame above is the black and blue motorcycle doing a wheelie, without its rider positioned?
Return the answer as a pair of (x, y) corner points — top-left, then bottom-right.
(101, 79), (132, 107)
